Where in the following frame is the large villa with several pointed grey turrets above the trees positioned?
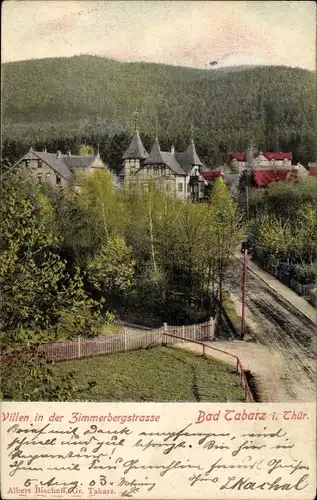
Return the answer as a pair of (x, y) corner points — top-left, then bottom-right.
(119, 130), (206, 201)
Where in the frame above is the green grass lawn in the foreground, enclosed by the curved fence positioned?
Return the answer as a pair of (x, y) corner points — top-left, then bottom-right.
(54, 347), (244, 402)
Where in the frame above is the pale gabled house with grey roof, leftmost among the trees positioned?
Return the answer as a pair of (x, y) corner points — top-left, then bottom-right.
(13, 148), (108, 188)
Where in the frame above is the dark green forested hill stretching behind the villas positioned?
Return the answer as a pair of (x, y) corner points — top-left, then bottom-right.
(2, 56), (316, 166)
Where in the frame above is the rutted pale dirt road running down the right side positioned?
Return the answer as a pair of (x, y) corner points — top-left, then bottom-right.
(221, 262), (316, 401)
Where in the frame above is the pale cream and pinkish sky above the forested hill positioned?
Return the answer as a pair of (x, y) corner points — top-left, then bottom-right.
(1, 0), (316, 70)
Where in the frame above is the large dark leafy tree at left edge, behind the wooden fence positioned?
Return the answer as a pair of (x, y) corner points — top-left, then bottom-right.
(0, 172), (99, 346)
